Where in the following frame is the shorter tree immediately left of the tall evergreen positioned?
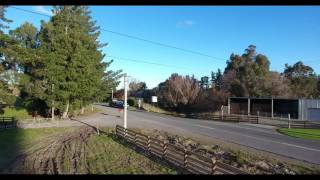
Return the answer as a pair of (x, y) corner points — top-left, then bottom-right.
(10, 22), (47, 115)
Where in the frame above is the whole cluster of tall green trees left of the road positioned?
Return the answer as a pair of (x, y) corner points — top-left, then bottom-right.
(0, 6), (121, 118)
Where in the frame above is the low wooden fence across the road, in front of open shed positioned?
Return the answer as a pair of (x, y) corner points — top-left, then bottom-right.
(186, 114), (259, 124)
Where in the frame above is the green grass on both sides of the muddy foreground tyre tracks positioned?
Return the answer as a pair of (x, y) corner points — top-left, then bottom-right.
(0, 127), (177, 174)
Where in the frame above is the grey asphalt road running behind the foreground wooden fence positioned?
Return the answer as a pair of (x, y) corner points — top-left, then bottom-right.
(89, 106), (320, 164)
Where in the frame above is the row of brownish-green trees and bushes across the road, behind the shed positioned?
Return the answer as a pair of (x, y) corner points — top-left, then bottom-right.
(136, 45), (320, 112)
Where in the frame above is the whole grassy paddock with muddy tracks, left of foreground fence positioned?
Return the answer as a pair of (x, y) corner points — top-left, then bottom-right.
(0, 128), (177, 174)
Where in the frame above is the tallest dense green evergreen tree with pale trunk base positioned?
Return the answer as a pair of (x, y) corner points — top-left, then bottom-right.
(40, 6), (120, 118)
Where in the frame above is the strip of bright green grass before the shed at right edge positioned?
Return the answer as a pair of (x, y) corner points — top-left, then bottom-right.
(278, 128), (320, 140)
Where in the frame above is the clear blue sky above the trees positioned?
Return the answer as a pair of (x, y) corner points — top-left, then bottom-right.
(6, 6), (320, 88)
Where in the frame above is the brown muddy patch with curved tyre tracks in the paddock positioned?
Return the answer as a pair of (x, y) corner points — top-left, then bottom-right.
(5, 127), (96, 174)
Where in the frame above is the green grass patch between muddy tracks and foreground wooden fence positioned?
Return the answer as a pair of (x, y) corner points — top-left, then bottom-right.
(87, 129), (176, 174)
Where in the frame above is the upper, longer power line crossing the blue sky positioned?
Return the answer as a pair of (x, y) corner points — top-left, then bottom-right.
(9, 6), (226, 61)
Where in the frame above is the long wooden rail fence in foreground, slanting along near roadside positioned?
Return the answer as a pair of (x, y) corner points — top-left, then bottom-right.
(116, 125), (249, 174)
